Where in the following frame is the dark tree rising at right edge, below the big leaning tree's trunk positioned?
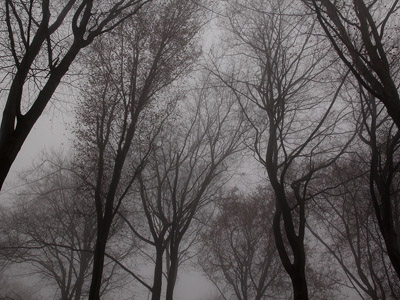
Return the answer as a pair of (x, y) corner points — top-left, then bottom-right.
(360, 91), (400, 278)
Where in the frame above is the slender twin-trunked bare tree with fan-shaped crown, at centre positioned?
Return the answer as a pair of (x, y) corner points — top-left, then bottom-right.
(119, 81), (245, 300)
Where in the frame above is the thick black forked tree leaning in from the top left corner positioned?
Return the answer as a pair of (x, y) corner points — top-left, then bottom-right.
(0, 0), (153, 189)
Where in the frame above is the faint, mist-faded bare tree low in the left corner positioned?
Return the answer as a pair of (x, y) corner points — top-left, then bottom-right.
(0, 154), (118, 300)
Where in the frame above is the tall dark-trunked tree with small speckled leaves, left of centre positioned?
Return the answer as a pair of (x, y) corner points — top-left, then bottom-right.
(73, 0), (203, 300)
